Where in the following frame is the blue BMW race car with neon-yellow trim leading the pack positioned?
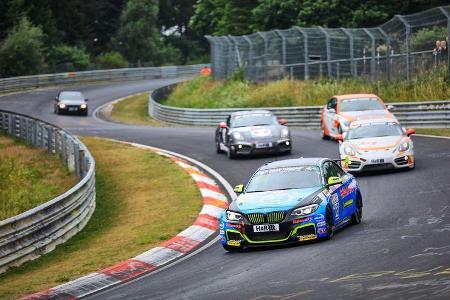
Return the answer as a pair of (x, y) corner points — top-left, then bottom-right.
(220, 158), (363, 251)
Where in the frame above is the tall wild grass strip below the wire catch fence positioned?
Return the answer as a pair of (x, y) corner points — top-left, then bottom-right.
(163, 68), (450, 108)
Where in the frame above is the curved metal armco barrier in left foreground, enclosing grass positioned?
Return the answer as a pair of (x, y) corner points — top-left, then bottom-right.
(0, 110), (95, 273)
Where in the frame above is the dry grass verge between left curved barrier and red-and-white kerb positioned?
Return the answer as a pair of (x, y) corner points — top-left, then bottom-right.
(0, 137), (202, 299)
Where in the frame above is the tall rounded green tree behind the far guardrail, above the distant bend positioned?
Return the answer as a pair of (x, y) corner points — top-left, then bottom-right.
(117, 0), (162, 65)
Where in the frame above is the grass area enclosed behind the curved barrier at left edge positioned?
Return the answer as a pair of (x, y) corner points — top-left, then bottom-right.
(0, 134), (77, 220)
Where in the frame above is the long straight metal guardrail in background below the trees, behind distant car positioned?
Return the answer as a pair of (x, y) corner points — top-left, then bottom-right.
(0, 64), (209, 93)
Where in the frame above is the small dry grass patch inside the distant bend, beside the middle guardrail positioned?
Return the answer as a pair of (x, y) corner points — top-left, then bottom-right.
(110, 93), (168, 127)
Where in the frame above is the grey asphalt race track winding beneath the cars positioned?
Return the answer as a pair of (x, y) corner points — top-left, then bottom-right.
(0, 79), (450, 300)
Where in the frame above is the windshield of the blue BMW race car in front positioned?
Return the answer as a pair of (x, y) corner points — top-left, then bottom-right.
(245, 166), (322, 193)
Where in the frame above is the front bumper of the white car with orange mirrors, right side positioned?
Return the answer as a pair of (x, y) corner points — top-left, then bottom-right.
(341, 151), (414, 172)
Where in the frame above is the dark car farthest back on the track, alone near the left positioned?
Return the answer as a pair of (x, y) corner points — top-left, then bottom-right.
(53, 91), (88, 116)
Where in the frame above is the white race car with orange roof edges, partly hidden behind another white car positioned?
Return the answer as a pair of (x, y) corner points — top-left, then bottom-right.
(321, 94), (397, 139)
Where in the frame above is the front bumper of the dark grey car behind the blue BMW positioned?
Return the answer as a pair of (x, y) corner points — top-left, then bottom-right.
(230, 139), (292, 155)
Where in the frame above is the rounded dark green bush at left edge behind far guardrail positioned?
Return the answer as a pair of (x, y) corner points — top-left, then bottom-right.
(0, 17), (45, 77)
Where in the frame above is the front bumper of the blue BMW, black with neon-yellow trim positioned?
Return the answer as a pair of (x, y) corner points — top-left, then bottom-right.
(220, 208), (327, 248)
